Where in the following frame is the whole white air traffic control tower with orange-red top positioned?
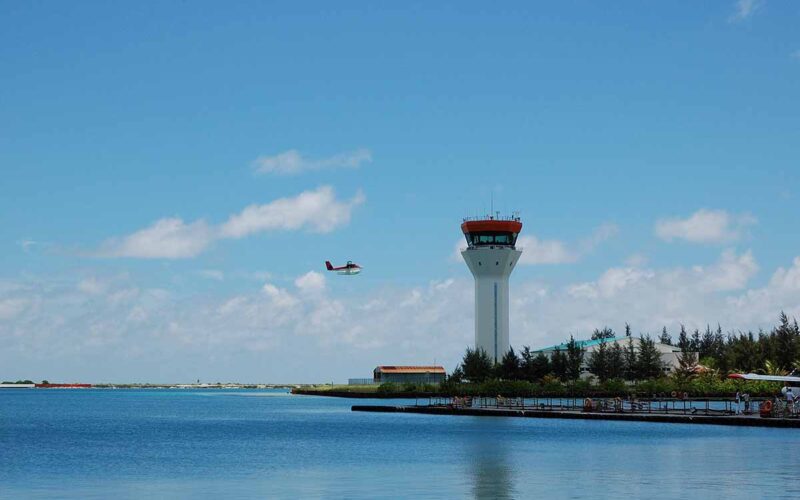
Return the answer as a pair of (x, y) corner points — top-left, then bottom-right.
(461, 216), (522, 363)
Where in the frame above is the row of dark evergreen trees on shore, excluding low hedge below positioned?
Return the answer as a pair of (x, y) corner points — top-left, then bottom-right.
(449, 312), (800, 383)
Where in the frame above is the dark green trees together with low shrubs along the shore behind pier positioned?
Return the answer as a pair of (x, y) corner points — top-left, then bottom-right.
(438, 312), (800, 396)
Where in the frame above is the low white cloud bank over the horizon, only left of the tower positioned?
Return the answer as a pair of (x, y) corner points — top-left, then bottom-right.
(0, 271), (472, 381)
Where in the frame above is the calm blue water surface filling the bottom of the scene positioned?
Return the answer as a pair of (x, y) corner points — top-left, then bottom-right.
(0, 389), (800, 498)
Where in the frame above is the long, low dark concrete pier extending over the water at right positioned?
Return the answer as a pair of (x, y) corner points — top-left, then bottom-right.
(351, 405), (800, 428)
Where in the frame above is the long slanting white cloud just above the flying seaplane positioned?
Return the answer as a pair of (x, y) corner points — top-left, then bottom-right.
(94, 186), (365, 259)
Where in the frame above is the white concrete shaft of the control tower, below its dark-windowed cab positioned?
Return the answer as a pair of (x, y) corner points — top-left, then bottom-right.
(461, 246), (522, 363)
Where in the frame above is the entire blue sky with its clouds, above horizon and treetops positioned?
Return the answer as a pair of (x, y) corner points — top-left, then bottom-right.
(0, 0), (800, 381)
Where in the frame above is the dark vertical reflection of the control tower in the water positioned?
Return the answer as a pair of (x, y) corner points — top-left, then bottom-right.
(466, 418), (516, 499)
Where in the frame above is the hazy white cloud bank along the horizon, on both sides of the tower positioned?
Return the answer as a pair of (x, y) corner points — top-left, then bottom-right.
(0, 250), (800, 382)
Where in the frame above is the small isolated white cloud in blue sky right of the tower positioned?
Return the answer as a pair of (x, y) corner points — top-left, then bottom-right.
(655, 209), (757, 243)
